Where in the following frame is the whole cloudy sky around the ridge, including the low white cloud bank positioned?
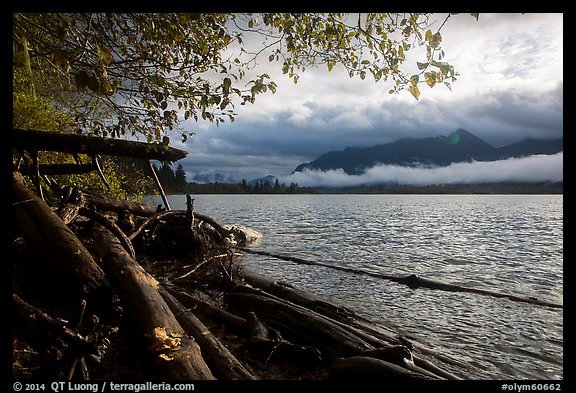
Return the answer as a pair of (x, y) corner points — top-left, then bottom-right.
(165, 13), (563, 185)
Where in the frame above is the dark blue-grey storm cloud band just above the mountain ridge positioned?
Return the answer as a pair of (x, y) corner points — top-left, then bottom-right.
(183, 80), (563, 181)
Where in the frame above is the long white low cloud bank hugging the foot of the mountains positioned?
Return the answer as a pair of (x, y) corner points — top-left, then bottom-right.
(279, 152), (564, 188)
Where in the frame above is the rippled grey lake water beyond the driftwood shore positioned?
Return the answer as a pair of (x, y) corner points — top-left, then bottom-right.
(145, 194), (564, 380)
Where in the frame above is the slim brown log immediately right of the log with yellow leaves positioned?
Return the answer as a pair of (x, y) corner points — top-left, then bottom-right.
(159, 286), (255, 380)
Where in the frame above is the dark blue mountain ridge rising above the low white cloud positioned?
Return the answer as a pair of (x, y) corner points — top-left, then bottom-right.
(294, 128), (564, 175)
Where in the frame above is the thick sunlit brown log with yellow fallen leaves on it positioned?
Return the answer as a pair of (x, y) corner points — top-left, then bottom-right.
(93, 225), (215, 380)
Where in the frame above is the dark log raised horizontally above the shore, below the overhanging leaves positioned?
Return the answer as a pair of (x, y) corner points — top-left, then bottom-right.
(12, 128), (188, 161)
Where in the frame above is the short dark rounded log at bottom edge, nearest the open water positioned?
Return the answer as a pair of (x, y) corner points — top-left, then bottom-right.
(330, 356), (432, 380)
